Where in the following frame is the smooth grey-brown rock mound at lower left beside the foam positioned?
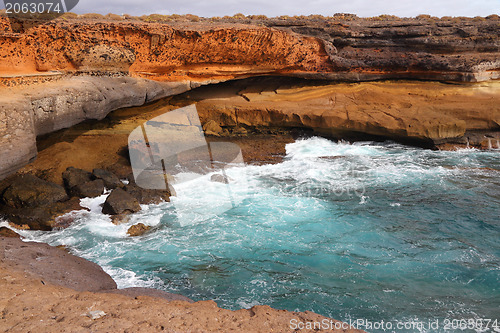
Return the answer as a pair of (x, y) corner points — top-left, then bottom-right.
(0, 238), (116, 292)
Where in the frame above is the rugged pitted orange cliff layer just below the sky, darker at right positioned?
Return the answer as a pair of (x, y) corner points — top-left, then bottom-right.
(0, 16), (500, 82)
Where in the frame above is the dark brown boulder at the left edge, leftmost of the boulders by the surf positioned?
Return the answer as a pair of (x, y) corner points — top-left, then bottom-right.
(2, 174), (68, 208)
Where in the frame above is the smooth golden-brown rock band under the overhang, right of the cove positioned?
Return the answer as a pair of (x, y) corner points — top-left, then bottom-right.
(193, 80), (500, 147)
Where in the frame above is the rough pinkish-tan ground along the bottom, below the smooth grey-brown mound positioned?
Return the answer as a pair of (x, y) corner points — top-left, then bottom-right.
(0, 249), (362, 333)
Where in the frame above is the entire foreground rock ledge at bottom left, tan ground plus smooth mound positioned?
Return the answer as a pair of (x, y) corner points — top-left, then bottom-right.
(0, 238), (362, 332)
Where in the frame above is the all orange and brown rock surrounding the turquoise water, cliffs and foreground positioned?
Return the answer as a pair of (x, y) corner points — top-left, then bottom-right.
(0, 15), (500, 332)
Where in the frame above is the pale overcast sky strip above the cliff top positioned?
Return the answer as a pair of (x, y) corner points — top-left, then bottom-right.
(0, 0), (500, 17)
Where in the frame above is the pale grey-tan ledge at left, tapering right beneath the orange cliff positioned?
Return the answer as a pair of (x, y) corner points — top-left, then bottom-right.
(0, 77), (190, 179)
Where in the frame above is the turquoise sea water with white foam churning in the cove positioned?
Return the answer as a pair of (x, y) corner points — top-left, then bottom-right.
(15, 138), (500, 332)
